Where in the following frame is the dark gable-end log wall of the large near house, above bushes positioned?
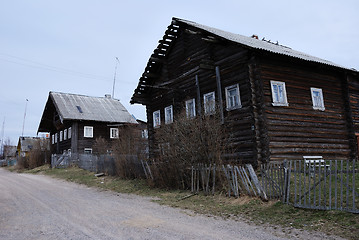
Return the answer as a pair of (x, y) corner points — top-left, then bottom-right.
(146, 26), (257, 164)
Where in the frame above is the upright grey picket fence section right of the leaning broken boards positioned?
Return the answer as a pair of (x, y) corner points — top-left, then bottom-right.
(261, 160), (359, 213)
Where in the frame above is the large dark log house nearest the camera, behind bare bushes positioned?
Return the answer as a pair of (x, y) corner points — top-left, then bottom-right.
(131, 18), (359, 164)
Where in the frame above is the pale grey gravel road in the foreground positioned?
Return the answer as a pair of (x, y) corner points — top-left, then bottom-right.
(0, 168), (344, 240)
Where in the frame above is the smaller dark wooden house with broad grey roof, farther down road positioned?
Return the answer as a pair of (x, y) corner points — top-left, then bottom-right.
(38, 92), (137, 154)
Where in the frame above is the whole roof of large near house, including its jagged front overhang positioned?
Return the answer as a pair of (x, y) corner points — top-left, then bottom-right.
(131, 17), (356, 103)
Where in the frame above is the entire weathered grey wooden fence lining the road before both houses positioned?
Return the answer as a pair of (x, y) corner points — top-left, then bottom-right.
(51, 154), (359, 213)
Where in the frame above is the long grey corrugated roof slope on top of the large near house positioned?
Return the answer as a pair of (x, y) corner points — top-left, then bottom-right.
(173, 18), (356, 71)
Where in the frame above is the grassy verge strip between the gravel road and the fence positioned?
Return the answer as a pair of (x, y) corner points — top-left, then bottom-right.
(21, 166), (359, 239)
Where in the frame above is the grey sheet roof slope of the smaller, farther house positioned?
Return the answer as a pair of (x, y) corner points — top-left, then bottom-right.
(50, 92), (137, 124)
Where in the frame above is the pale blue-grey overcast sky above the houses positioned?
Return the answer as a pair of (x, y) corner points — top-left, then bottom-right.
(0, 0), (359, 145)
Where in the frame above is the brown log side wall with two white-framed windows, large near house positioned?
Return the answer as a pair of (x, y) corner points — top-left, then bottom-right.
(261, 59), (350, 160)
